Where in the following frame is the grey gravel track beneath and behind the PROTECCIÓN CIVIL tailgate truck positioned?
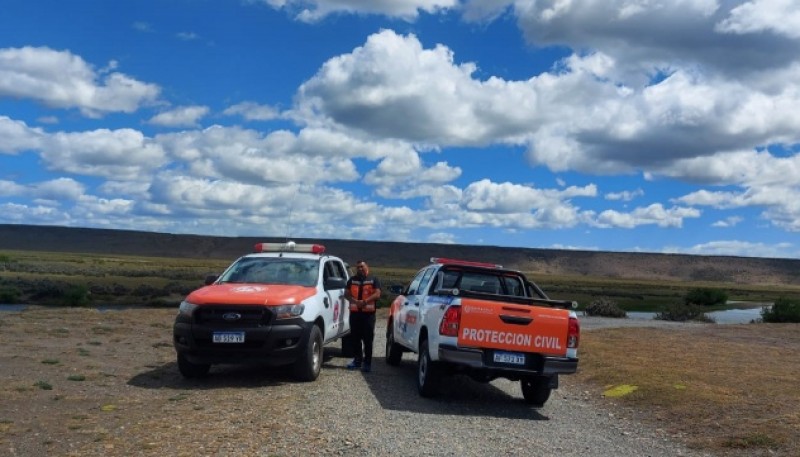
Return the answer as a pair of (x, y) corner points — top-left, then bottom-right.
(282, 317), (708, 457)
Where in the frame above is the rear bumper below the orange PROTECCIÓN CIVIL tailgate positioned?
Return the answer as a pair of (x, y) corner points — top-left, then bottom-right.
(439, 345), (578, 377)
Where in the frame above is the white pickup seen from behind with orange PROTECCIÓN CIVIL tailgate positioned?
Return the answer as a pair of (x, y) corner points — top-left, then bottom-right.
(386, 258), (580, 407)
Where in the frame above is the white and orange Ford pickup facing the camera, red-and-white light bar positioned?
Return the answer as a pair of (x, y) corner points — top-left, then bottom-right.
(173, 241), (350, 381)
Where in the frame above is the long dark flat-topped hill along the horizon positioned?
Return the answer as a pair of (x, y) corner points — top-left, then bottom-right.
(0, 224), (800, 286)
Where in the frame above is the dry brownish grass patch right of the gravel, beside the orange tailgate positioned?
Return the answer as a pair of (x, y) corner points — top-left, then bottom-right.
(576, 324), (800, 456)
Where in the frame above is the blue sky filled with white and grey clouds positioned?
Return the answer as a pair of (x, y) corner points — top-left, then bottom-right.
(0, 0), (800, 258)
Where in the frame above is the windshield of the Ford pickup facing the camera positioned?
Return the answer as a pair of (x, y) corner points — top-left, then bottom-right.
(219, 257), (319, 287)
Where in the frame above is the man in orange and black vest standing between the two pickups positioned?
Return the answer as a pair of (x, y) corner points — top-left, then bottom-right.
(344, 260), (381, 373)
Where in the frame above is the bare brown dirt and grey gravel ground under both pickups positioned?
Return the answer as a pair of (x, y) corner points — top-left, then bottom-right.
(0, 310), (709, 457)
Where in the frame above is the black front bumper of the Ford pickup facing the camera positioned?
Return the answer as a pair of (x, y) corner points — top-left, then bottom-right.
(173, 316), (314, 366)
